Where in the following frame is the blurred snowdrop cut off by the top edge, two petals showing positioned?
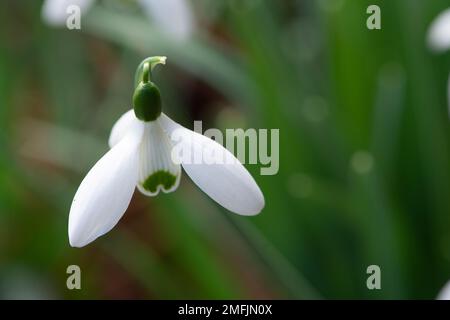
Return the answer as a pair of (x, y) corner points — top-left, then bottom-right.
(42, 0), (194, 40)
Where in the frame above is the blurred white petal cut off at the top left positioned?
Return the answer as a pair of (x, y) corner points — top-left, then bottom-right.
(42, 0), (94, 26)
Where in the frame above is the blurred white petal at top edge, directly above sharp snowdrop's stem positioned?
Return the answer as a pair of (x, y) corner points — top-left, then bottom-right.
(139, 0), (194, 40)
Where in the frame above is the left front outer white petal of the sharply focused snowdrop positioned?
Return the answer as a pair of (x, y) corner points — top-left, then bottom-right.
(69, 120), (143, 247)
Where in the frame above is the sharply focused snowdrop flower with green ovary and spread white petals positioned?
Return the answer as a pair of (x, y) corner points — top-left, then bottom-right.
(69, 57), (264, 247)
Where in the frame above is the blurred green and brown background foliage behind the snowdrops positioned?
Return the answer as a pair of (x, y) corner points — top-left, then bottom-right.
(0, 0), (450, 299)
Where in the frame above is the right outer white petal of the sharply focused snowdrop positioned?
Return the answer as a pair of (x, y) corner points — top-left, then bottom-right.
(160, 114), (264, 215)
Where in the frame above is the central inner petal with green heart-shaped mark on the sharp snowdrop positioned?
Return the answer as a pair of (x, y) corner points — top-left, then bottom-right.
(138, 120), (181, 196)
